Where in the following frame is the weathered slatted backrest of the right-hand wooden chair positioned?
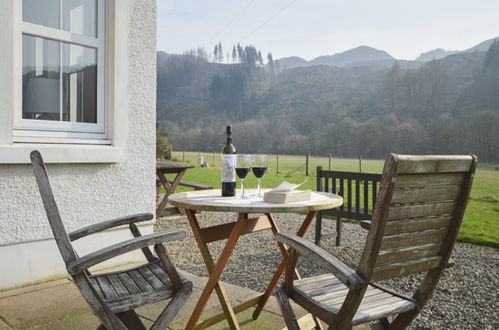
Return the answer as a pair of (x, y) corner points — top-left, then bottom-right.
(359, 155), (476, 280)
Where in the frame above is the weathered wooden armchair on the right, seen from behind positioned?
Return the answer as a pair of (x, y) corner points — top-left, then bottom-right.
(276, 155), (476, 329)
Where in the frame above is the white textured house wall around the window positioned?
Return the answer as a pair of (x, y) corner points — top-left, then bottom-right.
(0, 0), (156, 289)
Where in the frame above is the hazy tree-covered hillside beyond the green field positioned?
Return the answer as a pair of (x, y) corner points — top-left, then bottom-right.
(157, 40), (499, 161)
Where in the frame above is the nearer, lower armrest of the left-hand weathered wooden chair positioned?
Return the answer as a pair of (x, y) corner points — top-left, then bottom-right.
(67, 229), (185, 275)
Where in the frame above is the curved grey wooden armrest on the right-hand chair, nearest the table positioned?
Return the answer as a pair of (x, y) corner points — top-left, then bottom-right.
(276, 233), (364, 289)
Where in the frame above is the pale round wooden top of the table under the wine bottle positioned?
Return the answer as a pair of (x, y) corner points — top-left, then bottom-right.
(168, 189), (343, 213)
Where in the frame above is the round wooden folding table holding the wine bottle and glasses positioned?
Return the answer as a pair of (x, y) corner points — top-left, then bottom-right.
(169, 189), (343, 329)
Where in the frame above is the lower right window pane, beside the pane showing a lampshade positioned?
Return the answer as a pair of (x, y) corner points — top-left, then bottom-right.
(62, 43), (97, 123)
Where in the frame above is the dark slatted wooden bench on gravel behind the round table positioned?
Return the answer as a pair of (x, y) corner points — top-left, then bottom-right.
(315, 166), (381, 246)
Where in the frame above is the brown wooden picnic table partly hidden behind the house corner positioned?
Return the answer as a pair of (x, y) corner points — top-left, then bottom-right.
(156, 162), (194, 217)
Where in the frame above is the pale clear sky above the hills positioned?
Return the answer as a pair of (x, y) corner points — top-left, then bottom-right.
(157, 0), (499, 60)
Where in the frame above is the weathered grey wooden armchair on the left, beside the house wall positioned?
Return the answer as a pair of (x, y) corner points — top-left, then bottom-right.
(31, 150), (192, 329)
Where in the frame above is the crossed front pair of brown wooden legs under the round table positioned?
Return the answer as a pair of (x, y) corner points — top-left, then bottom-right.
(186, 210), (248, 329)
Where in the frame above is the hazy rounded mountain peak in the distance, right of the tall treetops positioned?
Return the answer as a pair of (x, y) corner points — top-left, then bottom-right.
(310, 46), (395, 67)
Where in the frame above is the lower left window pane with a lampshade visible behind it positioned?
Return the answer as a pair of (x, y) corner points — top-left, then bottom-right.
(22, 34), (60, 120)
